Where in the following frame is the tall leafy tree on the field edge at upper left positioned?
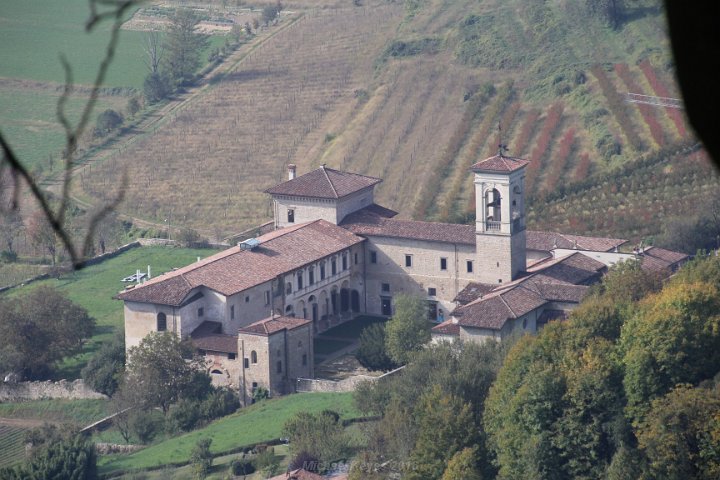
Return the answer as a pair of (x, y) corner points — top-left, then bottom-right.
(164, 8), (208, 85)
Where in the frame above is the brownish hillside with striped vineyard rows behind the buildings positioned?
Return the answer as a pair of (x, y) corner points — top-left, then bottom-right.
(79, 0), (718, 239)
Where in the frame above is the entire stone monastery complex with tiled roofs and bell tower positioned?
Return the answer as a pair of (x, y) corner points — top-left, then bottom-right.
(116, 155), (687, 401)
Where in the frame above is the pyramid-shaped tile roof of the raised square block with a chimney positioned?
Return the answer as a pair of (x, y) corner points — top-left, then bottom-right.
(265, 166), (382, 198)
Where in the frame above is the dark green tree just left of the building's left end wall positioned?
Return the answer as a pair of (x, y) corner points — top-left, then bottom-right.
(81, 333), (125, 396)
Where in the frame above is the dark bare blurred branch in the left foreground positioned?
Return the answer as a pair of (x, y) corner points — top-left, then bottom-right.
(0, 0), (142, 268)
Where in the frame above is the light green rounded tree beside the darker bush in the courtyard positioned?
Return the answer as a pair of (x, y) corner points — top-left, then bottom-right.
(385, 294), (430, 365)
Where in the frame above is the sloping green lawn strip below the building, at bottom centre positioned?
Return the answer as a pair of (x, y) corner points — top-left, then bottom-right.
(99, 393), (361, 474)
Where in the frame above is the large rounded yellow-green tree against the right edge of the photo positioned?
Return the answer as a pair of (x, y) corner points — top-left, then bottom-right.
(620, 283), (720, 421)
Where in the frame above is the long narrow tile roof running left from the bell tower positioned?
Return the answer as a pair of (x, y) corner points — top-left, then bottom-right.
(340, 209), (475, 245)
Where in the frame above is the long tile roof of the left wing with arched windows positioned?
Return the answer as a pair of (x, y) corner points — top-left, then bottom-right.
(116, 220), (363, 306)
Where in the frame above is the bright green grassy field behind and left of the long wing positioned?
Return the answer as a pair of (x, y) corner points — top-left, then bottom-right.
(2, 247), (216, 379)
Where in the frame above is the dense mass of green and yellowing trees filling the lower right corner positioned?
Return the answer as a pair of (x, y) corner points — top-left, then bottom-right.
(351, 256), (720, 480)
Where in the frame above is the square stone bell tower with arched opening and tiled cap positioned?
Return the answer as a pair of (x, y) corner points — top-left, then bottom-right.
(470, 153), (528, 284)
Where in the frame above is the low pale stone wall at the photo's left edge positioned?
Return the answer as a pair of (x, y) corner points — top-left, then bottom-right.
(0, 380), (107, 402)
